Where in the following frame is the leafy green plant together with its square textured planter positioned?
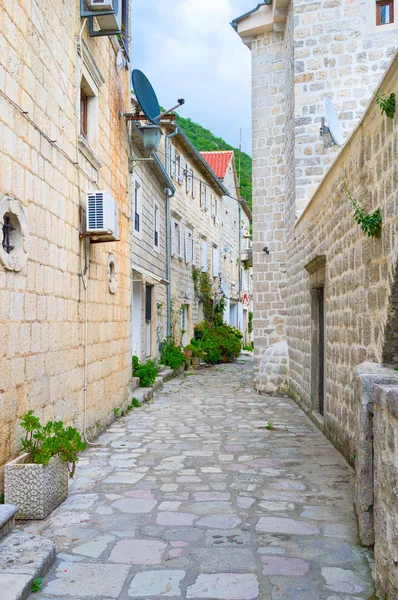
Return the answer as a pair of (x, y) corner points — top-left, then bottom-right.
(4, 410), (86, 519)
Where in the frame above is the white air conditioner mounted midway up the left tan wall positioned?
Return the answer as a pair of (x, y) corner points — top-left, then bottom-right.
(86, 190), (119, 242)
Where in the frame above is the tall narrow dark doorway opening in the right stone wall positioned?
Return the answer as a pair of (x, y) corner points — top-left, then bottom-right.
(311, 285), (325, 416)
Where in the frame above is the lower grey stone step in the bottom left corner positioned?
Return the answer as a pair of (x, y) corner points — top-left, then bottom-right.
(0, 531), (55, 600)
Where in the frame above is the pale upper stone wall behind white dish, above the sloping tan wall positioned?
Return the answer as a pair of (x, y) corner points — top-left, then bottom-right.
(292, 0), (398, 215)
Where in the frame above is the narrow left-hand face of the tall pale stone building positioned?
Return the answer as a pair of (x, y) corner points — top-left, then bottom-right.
(251, 33), (286, 393)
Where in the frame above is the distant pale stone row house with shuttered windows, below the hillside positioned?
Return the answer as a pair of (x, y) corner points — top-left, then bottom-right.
(160, 131), (250, 345)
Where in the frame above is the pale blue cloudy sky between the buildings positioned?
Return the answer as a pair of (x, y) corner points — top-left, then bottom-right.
(132, 0), (258, 153)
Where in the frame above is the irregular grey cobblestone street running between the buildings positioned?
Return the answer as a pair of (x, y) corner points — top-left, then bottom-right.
(25, 361), (373, 600)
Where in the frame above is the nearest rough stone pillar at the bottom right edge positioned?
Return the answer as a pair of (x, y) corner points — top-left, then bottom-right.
(373, 385), (398, 598)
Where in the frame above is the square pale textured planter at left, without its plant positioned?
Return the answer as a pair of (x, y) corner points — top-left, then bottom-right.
(4, 454), (69, 519)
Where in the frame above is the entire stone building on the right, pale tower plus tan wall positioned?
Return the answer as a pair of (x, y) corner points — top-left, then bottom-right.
(233, 0), (398, 597)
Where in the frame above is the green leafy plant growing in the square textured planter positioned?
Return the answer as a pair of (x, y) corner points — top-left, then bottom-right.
(20, 410), (86, 477)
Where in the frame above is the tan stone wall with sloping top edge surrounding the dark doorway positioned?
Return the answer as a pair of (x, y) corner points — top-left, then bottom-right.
(288, 57), (398, 460)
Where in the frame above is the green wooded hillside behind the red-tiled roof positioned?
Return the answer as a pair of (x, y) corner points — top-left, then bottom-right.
(176, 115), (252, 208)
